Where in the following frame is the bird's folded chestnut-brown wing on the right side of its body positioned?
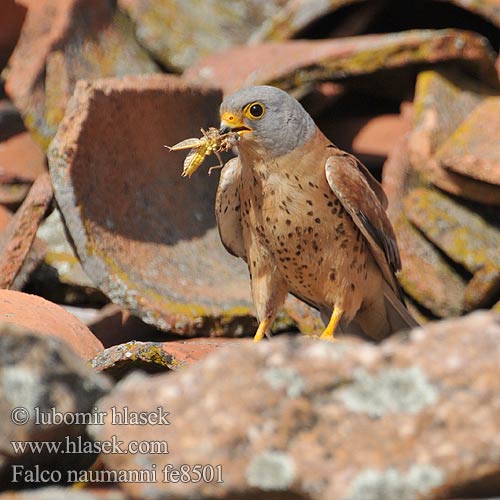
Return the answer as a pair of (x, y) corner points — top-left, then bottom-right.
(325, 150), (403, 292)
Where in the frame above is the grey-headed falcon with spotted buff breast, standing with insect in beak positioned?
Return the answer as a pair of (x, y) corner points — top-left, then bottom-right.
(215, 85), (418, 342)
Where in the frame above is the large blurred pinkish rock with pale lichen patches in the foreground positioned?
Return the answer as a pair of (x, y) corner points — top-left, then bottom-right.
(89, 312), (500, 500)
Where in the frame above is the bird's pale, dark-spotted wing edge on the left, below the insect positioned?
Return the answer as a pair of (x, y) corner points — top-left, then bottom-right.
(215, 158), (246, 260)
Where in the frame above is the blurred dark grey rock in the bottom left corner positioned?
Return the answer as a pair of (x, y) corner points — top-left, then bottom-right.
(0, 323), (112, 488)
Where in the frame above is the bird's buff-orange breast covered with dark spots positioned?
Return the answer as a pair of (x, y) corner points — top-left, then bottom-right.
(240, 163), (366, 304)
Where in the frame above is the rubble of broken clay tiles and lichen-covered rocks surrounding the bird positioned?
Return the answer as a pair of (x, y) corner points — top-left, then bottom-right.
(0, 0), (500, 500)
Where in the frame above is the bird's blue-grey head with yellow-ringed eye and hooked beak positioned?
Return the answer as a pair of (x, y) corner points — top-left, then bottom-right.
(220, 85), (316, 157)
